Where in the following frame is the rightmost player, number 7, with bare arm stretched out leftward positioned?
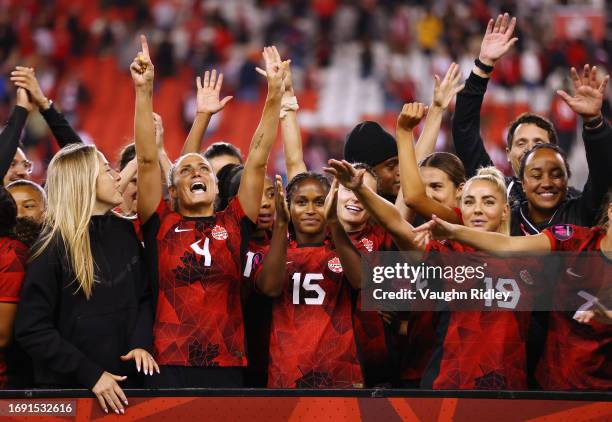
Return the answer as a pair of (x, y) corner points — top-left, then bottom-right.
(420, 193), (612, 390)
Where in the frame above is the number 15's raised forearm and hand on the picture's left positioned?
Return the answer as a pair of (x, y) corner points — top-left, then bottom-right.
(255, 175), (289, 297)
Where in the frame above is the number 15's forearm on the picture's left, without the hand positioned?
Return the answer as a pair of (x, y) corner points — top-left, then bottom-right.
(255, 221), (288, 297)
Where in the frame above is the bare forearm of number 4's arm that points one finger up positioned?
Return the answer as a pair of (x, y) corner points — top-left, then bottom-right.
(134, 87), (159, 165)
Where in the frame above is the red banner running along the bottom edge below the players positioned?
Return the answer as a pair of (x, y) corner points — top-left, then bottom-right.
(0, 397), (612, 422)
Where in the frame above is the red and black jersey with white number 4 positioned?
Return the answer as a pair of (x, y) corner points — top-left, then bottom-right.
(142, 199), (252, 366)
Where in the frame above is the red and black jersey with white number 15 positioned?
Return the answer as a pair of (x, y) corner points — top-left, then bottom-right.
(258, 243), (363, 388)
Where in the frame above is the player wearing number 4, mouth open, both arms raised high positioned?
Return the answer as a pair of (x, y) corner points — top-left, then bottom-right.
(130, 36), (284, 388)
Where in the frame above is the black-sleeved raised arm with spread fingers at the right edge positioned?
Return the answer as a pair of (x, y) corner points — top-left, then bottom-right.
(557, 64), (612, 225)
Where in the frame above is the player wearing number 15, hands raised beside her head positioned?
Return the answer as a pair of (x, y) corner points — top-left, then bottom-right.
(255, 172), (363, 388)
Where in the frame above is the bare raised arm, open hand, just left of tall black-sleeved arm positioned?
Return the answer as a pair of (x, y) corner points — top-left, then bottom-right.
(415, 63), (464, 162)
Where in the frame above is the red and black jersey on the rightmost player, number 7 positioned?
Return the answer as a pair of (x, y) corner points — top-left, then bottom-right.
(536, 224), (612, 390)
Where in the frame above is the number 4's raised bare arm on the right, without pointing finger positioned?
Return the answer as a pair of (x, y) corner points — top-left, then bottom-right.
(238, 47), (286, 222)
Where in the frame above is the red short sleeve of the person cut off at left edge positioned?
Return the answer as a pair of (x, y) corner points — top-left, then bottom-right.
(0, 241), (28, 303)
